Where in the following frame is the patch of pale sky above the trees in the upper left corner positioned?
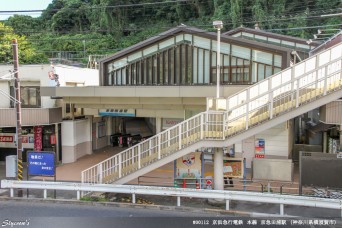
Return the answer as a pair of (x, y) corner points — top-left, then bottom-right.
(0, 0), (52, 20)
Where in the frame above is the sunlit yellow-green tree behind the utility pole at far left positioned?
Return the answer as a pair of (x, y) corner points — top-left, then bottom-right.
(0, 23), (48, 63)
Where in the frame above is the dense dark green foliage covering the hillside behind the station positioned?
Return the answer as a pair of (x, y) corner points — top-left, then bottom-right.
(0, 0), (342, 63)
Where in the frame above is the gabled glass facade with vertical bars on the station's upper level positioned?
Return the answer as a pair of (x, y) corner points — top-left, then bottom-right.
(104, 34), (282, 86)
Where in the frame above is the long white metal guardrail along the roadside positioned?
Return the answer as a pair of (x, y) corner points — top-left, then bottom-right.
(1, 180), (342, 218)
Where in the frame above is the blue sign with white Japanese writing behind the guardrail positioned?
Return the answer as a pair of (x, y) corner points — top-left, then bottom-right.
(27, 152), (55, 176)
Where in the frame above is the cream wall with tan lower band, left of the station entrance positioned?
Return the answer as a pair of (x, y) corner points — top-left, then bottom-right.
(62, 119), (92, 163)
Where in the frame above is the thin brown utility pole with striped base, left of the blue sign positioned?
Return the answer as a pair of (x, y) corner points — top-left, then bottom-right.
(12, 39), (23, 189)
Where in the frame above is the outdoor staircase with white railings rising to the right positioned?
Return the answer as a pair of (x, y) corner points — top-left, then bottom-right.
(82, 43), (342, 184)
